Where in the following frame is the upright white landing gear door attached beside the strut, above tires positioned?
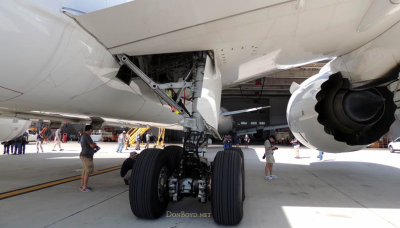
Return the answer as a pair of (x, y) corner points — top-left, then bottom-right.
(197, 56), (222, 133)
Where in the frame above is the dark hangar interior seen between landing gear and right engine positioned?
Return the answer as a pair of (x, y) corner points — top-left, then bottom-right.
(166, 61), (327, 143)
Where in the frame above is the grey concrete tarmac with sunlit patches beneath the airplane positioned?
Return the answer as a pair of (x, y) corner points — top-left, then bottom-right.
(0, 142), (400, 228)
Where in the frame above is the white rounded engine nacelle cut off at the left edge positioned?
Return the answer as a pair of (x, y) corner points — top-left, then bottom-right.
(0, 118), (32, 142)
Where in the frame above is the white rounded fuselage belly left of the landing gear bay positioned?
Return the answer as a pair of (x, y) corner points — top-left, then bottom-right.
(0, 1), (180, 124)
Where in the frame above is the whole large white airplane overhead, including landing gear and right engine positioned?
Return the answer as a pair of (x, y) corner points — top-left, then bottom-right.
(0, 0), (400, 225)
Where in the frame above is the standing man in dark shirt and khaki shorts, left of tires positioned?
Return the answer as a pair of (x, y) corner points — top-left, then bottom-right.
(79, 125), (98, 192)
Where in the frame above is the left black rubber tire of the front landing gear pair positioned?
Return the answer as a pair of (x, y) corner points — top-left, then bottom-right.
(129, 149), (169, 219)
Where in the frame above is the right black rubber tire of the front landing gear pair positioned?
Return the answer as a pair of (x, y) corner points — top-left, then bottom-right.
(211, 150), (244, 225)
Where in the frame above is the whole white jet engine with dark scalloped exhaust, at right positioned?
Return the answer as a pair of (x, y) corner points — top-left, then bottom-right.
(287, 73), (396, 152)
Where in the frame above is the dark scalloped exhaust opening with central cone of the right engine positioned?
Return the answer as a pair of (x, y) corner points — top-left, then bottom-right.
(315, 73), (396, 145)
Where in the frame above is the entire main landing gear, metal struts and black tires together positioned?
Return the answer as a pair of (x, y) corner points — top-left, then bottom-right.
(117, 52), (245, 225)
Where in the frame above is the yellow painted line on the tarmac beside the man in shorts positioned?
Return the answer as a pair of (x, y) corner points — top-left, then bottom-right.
(0, 165), (121, 200)
